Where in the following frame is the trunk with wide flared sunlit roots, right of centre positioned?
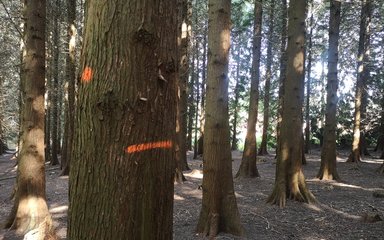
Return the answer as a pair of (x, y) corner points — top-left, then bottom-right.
(268, 0), (314, 207)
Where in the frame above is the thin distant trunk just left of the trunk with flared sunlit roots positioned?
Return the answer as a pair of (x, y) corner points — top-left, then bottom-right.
(259, 0), (275, 155)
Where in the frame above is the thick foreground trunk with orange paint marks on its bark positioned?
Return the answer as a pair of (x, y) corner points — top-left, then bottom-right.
(68, 0), (178, 240)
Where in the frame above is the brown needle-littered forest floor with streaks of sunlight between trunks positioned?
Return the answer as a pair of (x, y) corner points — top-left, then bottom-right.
(0, 150), (384, 240)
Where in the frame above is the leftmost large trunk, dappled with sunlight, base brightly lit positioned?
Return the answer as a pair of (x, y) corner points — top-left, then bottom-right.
(6, 0), (52, 236)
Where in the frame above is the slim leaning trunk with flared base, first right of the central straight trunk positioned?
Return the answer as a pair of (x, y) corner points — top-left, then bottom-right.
(236, 0), (263, 177)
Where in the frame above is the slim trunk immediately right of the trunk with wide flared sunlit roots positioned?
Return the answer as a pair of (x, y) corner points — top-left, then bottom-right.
(317, 0), (341, 180)
